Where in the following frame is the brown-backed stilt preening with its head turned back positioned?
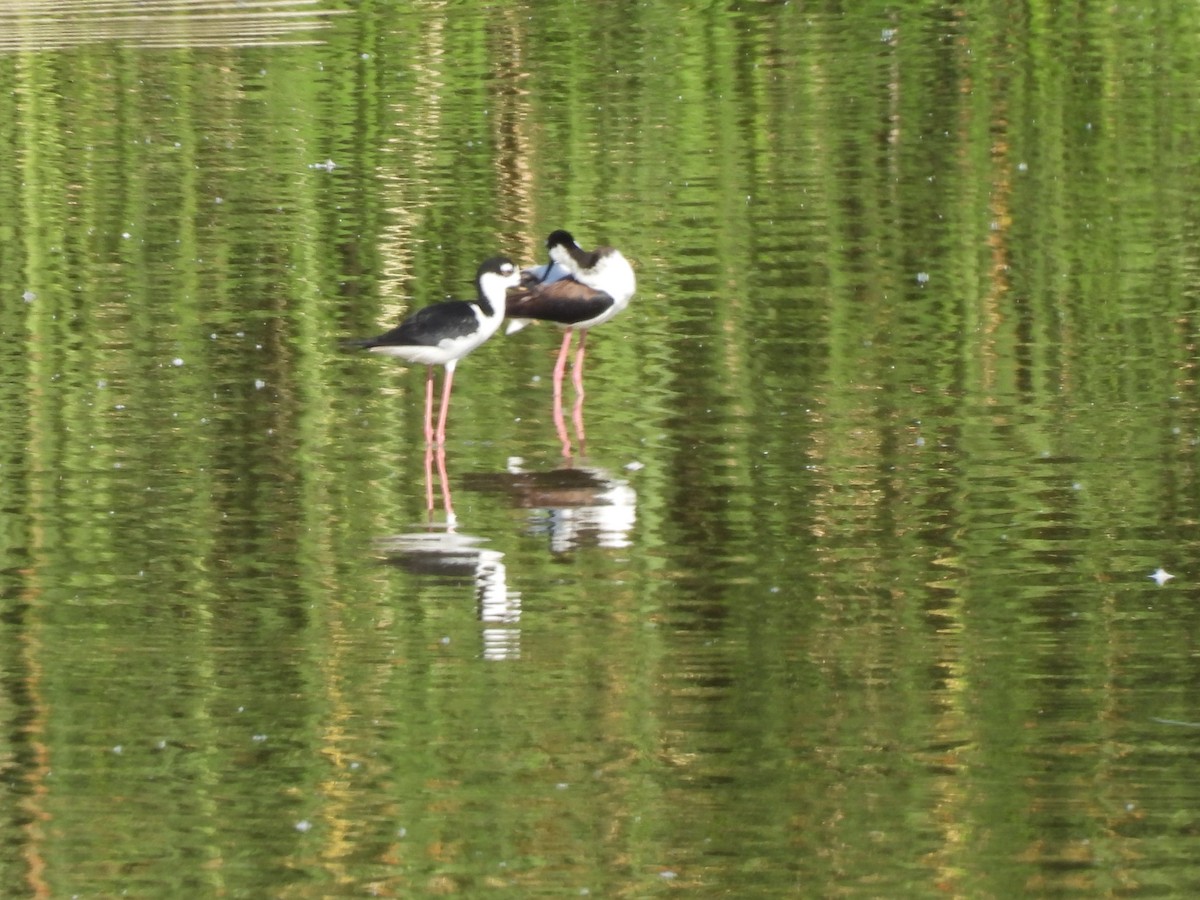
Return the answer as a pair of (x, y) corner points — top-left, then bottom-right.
(508, 229), (637, 455)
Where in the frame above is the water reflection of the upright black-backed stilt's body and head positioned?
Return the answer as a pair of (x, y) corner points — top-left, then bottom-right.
(379, 526), (521, 661)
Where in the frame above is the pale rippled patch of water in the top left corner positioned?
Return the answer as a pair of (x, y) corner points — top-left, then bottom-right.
(0, 0), (349, 53)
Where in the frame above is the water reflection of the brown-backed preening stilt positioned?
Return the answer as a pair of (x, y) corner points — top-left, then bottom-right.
(464, 458), (637, 553)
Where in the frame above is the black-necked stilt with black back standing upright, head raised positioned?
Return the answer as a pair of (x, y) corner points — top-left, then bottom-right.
(348, 257), (521, 444)
